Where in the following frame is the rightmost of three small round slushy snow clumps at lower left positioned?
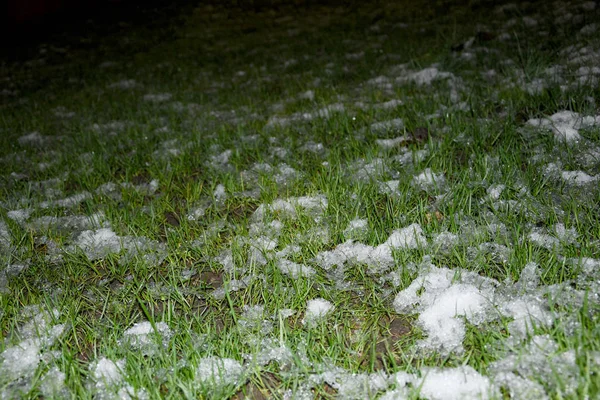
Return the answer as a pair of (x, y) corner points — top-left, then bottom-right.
(196, 357), (246, 391)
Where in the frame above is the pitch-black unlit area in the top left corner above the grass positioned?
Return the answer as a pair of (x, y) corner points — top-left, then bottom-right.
(0, 0), (198, 62)
